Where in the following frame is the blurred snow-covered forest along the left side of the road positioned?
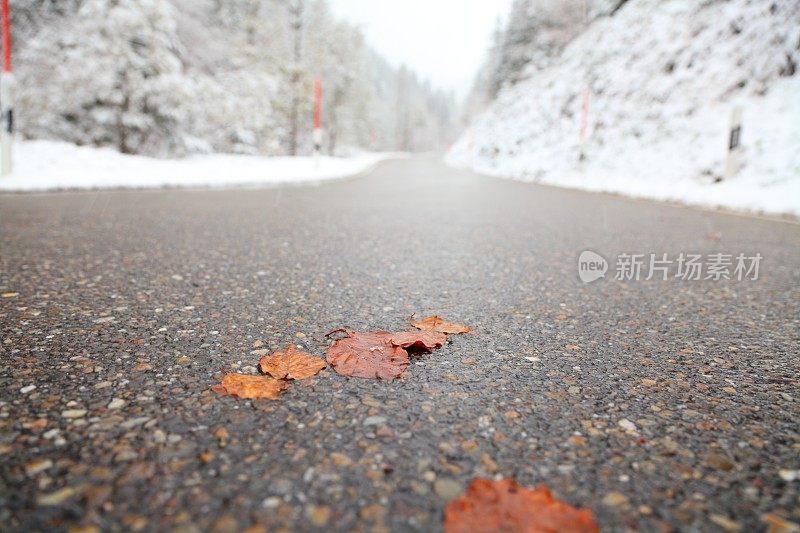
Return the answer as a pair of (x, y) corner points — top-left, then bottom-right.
(12, 0), (457, 156)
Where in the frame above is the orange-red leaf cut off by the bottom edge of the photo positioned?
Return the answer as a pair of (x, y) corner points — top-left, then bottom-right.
(444, 479), (599, 533)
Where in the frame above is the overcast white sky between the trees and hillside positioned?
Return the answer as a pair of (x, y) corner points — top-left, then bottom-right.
(330, 0), (511, 97)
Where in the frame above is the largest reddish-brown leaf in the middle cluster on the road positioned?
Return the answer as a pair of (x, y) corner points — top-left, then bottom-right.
(326, 330), (409, 381)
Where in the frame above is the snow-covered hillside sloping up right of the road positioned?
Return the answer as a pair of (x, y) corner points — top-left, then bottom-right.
(448, 0), (800, 215)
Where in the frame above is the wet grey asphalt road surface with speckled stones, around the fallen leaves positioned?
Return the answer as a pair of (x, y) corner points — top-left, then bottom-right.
(0, 159), (800, 531)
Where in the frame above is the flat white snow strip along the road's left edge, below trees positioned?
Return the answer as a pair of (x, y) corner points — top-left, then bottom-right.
(0, 141), (388, 191)
